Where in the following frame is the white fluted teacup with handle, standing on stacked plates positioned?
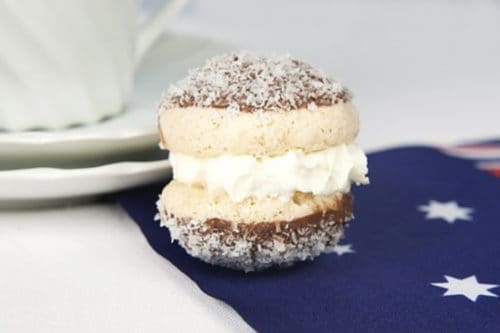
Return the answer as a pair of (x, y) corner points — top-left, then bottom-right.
(0, 0), (184, 131)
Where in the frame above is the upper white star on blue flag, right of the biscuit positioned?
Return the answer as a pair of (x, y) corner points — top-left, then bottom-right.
(418, 200), (474, 224)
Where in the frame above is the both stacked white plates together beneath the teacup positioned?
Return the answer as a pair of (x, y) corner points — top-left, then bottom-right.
(0, 34), (229, 207)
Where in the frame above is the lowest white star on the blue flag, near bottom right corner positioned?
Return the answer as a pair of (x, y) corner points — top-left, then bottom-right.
(431, 275), (498, 302)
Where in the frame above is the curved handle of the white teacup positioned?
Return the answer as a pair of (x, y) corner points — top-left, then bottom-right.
(135, 0), (188, 65)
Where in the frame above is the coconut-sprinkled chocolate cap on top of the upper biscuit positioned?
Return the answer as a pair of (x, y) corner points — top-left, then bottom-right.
(162, 51), (351, 112)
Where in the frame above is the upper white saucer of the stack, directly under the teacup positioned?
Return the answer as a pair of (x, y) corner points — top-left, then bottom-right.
(0, 34), (230, 166)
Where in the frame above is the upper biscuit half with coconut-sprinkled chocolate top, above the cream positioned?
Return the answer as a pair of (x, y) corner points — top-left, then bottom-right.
(159, 53), (359, 158)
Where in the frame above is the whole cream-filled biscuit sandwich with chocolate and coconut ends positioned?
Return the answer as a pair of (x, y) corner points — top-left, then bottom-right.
(157, 52), (369, 272)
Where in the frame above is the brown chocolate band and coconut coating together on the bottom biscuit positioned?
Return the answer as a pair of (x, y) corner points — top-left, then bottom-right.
(158, 194), (352, 272)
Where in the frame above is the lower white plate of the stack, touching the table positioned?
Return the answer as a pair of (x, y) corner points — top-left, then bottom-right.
(0, 160), (171, 207)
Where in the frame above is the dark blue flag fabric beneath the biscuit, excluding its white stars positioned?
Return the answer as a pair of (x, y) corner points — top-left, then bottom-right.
(112, 147), (500, 332)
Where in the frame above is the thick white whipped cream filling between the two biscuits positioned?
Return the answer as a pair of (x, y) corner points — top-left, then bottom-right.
(170, 144), (369, 202)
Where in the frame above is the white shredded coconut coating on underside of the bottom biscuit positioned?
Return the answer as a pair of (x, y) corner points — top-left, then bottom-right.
(157, 201), (352, 272)
